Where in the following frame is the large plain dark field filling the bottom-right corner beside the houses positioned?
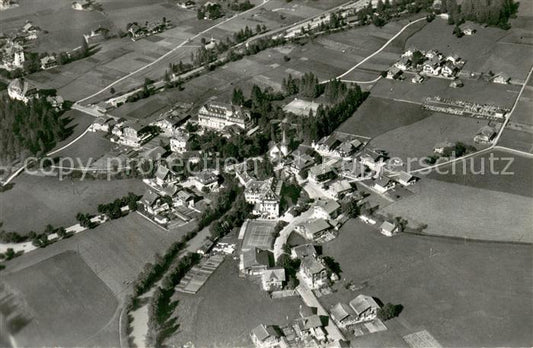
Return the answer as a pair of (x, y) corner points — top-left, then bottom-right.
(321, 220), (533, 347)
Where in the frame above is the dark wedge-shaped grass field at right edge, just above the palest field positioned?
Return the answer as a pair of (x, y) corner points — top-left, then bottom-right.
(428, 151), (533, 198)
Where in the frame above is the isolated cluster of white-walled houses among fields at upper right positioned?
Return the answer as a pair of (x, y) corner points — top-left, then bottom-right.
(387, 48), (465, 83)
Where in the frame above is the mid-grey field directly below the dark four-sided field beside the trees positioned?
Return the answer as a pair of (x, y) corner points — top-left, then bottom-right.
(370, 110), (488, 169)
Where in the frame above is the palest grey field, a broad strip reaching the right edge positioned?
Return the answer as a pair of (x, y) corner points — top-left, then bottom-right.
(382, 178), (533, 243)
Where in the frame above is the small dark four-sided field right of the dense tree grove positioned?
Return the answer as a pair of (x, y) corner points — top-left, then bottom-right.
(338, 96), (431, 138)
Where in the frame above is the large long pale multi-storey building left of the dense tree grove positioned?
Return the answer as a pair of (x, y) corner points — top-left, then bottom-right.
(198, 103), (251, 131)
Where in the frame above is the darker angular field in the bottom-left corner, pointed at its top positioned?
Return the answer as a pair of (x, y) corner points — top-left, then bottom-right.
(3, 251), (118, 347)
